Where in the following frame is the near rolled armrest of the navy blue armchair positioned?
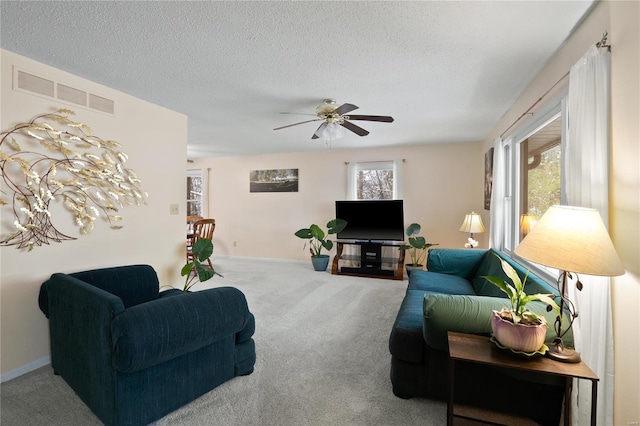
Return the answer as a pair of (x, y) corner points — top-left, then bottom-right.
(111, 287), (250, 373)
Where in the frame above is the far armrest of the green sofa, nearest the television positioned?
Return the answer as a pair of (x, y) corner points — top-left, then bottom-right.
(427, 248), (487, 279)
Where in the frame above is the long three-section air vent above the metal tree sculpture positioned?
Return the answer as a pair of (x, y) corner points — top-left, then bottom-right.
(13, 66), (115, 115)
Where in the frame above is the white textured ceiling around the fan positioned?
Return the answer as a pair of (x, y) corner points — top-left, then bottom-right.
(0, 0), (597, 158)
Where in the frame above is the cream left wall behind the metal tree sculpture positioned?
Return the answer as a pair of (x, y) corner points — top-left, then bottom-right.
(0, 50), (187, 380)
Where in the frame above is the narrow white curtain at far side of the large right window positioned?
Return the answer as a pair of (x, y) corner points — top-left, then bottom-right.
(489, 137), (507, 250)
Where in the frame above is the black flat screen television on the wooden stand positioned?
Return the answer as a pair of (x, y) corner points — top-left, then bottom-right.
(336, 200), (404, 241)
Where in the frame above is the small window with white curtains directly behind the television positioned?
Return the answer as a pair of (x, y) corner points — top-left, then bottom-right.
(347, 160), (402, 200)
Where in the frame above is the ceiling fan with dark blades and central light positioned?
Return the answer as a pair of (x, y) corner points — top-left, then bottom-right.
(273, 99), (393, 139)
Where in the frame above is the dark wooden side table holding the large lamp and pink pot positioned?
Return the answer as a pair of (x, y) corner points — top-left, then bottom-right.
(447, 331), (598, 426)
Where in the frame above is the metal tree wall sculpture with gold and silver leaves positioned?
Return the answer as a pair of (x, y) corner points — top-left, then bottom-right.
(0, 109), (148, 251)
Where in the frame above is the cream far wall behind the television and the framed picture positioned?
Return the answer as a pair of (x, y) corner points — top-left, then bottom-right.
(189, 141), (489, 260)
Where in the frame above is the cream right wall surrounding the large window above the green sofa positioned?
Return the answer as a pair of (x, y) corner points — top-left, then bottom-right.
(483, 1), (640, 425)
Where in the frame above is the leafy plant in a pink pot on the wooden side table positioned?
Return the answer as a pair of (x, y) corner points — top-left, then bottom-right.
(483, 255), (560, 353)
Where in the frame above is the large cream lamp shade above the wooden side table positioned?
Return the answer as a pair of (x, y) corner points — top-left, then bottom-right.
(515, 206), (624, 276)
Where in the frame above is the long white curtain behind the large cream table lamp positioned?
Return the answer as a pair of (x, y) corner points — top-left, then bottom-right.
(564, 46), (613, 425)
